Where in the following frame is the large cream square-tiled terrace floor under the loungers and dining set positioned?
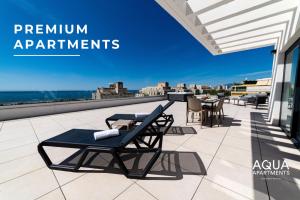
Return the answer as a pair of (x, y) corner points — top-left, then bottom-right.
(0, 102), (300, 200)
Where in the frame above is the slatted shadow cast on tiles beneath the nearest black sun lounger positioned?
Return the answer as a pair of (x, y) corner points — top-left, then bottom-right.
(55, 151), (206, 180)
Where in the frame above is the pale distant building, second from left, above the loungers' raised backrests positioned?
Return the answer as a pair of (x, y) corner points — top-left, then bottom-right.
(137, 82), (171, 96)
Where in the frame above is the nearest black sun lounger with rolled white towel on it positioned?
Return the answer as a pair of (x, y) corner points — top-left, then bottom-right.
(38, 105), (163, 178)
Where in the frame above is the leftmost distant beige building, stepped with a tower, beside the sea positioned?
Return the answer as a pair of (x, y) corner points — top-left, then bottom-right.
(92, 82), (134, 99)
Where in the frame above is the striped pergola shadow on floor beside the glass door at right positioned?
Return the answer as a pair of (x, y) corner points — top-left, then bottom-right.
(250, 111), (300, 199)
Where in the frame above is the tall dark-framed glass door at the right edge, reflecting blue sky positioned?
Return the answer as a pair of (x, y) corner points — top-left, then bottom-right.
(280, 41), (300, 141)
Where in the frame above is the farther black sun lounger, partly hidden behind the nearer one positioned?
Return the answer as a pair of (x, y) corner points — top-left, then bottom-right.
(105, 101), (174, 134)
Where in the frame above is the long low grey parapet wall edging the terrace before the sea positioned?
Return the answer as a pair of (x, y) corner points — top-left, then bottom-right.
(0, 96), (167, 121)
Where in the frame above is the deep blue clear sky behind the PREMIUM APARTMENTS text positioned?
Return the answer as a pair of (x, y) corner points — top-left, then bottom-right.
(0, 0), (273, 90)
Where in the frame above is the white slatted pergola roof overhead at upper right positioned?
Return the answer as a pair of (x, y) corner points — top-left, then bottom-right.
(156, 0), (300, 55)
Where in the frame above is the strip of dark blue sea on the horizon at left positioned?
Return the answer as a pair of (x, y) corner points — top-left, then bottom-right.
(0, 90), (138, 106)
